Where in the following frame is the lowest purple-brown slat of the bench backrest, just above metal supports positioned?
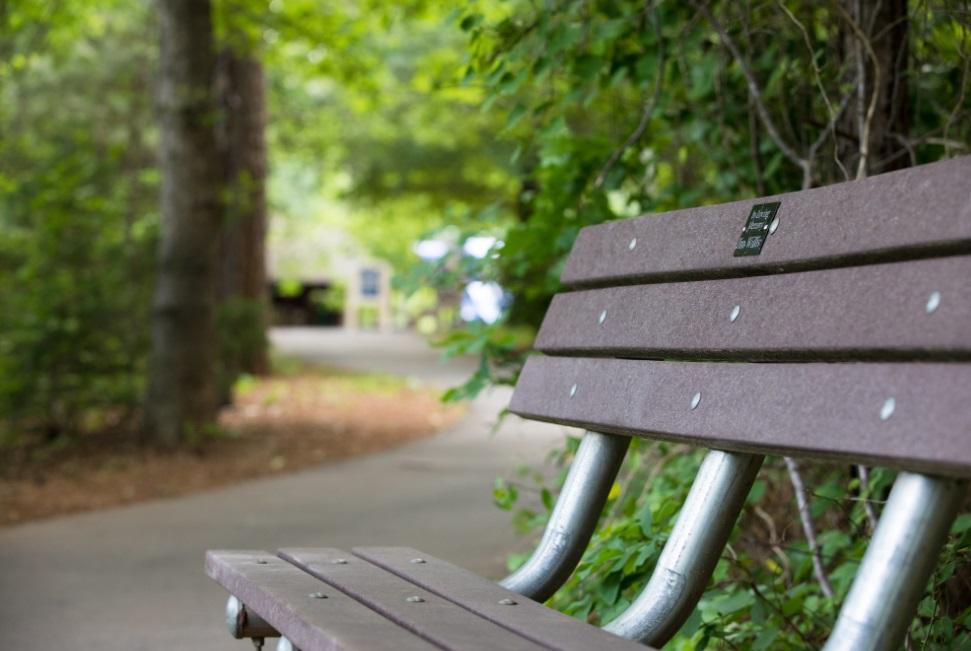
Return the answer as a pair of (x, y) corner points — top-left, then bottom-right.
(509, 356), (971, 477)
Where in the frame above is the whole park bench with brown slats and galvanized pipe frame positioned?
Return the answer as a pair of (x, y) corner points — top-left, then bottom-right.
(206, 157), (971, 651)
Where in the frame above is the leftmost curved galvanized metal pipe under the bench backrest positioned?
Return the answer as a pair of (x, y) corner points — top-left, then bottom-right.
(499, 432), (630, 601)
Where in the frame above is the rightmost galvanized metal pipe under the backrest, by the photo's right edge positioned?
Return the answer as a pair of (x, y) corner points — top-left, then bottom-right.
(824, 472), (967, 651)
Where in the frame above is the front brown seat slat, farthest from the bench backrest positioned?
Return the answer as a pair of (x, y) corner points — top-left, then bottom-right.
(206, 550), (437, 651)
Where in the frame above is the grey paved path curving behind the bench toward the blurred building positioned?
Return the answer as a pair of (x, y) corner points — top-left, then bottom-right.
(0, 330), (565, 651)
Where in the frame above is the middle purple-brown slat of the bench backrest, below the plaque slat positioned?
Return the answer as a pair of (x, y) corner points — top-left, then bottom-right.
(536, 256), (971, 360)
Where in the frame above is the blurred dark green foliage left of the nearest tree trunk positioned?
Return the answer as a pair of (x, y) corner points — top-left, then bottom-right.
(0, 3), (157, 437)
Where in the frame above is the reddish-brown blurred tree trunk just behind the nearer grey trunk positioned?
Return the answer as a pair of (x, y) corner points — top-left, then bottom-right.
(218, 49), (269, 381)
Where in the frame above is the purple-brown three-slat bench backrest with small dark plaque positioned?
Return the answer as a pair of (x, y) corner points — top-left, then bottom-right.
(510, 157), (971, 476)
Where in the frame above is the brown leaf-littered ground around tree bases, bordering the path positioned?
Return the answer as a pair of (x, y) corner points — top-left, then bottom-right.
(0, 368), (462, 527)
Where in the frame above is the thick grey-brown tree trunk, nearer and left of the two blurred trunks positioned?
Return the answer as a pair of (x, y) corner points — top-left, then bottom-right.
(145, 0), (221, 445)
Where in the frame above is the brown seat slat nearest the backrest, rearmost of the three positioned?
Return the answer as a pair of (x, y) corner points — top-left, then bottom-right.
(354, 547), (650, 651)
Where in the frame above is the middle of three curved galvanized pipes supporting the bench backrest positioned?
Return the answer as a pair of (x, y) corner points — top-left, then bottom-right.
(604, 450), (764, 648)
